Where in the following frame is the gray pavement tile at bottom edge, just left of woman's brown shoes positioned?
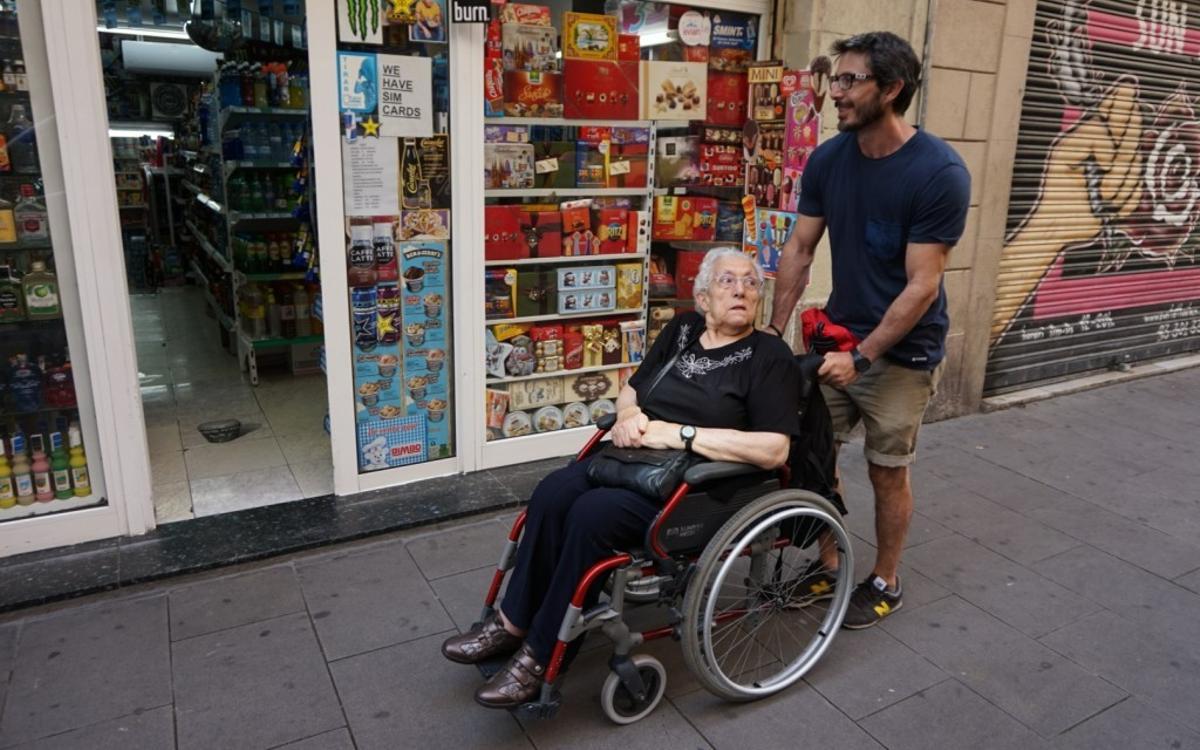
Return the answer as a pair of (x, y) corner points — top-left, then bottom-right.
(330, 636), (530, 750)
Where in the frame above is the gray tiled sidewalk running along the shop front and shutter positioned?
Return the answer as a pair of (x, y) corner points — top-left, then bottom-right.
(0, 368), (1200, 750)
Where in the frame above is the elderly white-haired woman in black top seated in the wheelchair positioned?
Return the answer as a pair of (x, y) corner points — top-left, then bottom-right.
(442, 247), (800, 708)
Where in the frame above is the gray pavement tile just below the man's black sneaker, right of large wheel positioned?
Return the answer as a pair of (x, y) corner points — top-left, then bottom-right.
(804, 624), (949, 719)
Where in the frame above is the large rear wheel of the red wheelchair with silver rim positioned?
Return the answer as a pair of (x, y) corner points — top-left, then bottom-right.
(682, 490), (854, 701)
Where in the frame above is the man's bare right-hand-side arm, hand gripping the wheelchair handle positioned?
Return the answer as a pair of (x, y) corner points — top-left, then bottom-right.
(817, 242), (950, 386)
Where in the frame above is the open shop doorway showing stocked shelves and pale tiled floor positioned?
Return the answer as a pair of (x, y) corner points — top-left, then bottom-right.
(97, 0), (332, 523)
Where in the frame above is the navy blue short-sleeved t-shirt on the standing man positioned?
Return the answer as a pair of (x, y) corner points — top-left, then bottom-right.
(799, 130), (971, 370)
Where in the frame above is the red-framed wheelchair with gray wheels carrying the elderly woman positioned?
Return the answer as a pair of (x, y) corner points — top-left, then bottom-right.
(476, 355), (854, 725)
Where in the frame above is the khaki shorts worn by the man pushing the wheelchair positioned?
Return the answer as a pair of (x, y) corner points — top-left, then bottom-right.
(821, 359), (944, 467)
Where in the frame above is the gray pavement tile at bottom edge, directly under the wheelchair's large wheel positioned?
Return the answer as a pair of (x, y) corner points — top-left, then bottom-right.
(676, 682), (880, 750)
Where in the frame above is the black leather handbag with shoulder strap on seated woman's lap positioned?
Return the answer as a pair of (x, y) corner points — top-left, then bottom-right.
(588, 324), (706, 502)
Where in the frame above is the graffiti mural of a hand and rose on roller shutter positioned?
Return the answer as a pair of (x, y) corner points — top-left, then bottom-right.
(984, 0), (1200, 392)
